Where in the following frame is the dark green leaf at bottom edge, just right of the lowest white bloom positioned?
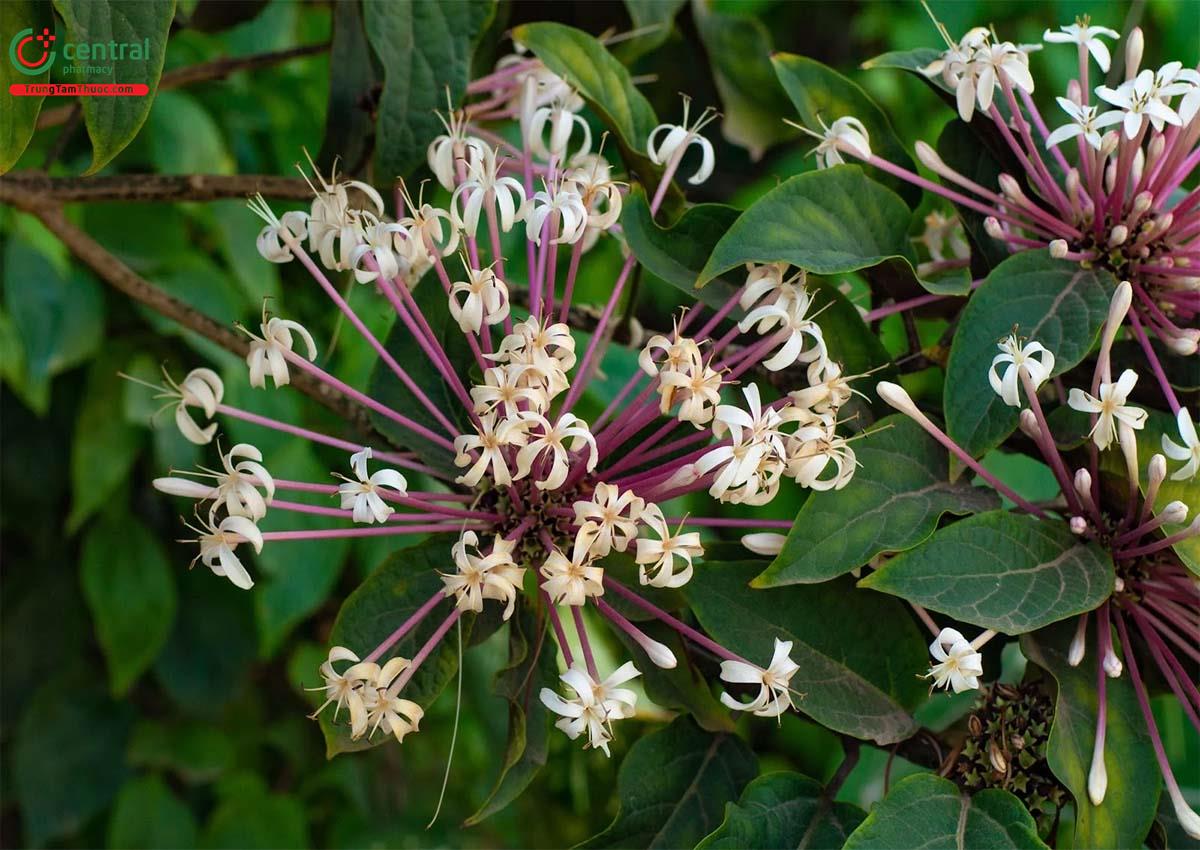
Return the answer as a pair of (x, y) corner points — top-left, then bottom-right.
(580, 717), (758, 849)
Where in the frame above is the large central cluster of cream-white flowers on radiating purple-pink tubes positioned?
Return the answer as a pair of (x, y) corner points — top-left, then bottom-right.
(140, 49), (878, 753)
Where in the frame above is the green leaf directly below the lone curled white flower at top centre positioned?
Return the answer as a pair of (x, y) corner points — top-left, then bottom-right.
(620, 185), (742, 307)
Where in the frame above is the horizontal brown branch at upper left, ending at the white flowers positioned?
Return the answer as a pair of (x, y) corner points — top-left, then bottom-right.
(0, 172), (312, 206)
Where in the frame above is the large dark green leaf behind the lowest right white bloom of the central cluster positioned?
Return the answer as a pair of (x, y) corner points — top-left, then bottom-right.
(684, 561), (925, 744)
